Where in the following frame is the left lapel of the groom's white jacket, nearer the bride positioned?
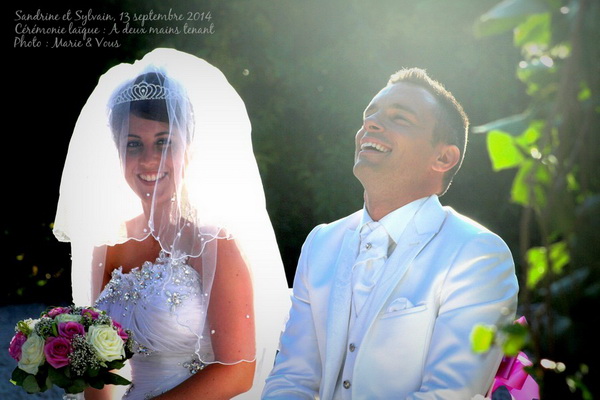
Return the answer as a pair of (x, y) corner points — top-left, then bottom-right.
(321, 230), (360, 399)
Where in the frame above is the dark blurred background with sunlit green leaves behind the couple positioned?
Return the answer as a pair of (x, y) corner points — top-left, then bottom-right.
(0, 0), (600, 399)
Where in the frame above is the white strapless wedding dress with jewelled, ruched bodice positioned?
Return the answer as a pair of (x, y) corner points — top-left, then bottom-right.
(96, 252), (214, 400)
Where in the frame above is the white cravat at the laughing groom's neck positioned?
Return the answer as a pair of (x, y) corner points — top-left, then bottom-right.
(352, 221), (390, 315)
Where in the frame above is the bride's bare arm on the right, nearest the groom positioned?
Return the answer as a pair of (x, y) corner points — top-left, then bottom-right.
(156, 240), (255, 400)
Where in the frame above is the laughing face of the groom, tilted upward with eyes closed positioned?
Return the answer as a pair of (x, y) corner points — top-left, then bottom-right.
(354, 82), (438, 197)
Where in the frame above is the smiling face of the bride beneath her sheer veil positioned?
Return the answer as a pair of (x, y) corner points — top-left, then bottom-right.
(122, 114), (184, 204)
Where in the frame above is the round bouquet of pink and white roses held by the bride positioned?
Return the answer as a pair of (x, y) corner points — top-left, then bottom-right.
(9, 306), (134, 393)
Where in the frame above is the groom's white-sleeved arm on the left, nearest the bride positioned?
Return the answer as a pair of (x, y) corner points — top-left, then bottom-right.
(262, 227), (321, 400)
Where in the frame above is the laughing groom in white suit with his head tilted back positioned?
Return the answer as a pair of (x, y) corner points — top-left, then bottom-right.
(263, 68), (518, 400)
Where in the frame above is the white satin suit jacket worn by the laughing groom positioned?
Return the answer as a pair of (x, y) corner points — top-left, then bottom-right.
(263, 196), (518, 400)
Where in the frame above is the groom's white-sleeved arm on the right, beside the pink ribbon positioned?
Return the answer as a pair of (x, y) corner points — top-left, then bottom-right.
(407, 232), (519, 400)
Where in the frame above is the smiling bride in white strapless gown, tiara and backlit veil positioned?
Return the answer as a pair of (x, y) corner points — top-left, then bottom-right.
(54, 49), (288, 399)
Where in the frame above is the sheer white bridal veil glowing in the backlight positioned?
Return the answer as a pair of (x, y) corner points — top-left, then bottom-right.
(54, 49), (289, 397)
